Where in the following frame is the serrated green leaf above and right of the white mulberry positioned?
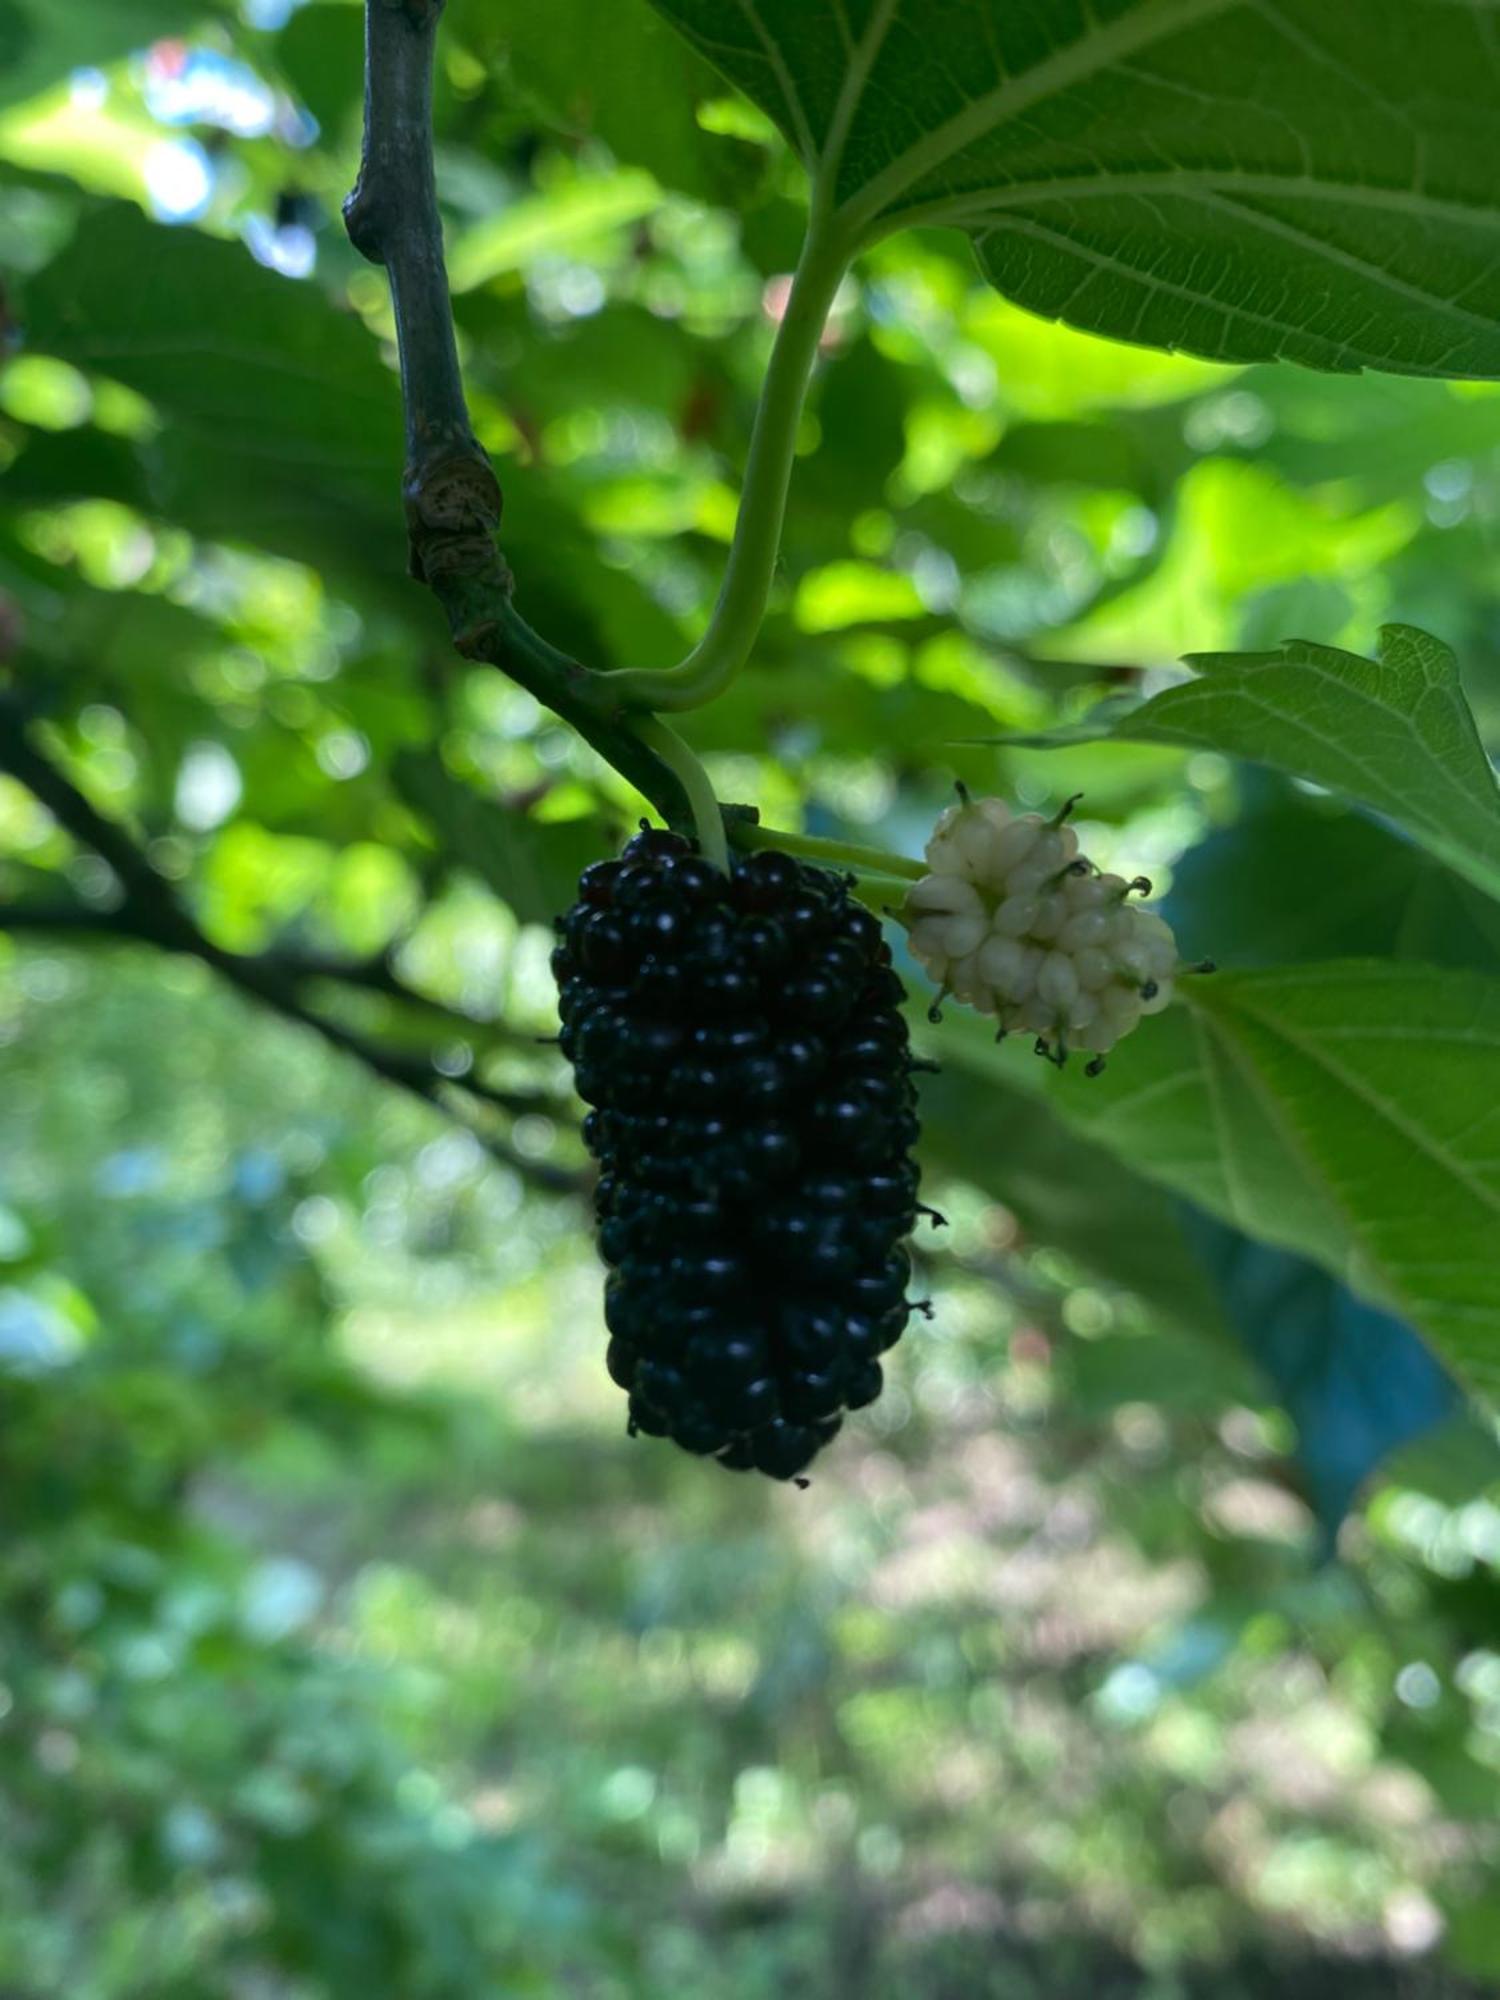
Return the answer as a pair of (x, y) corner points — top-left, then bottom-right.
(1020, 626), (1500, 896)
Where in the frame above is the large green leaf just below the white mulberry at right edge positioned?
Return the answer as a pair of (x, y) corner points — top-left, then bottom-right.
(938, 960), (1500, 1392)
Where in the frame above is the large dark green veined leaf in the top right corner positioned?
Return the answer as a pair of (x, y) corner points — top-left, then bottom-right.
(656, 0), (1500, 374)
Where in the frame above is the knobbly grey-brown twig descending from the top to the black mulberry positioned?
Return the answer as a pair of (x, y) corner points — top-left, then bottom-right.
(344, 0), (690, 826)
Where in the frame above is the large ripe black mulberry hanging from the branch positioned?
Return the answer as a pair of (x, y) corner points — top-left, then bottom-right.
(552, 830), (918, 1478)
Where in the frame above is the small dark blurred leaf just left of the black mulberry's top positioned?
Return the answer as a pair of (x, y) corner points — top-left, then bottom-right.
(390, 750), (606, 924)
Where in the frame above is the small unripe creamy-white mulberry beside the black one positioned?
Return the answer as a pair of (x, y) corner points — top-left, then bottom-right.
(904, 796), (1182, 1072)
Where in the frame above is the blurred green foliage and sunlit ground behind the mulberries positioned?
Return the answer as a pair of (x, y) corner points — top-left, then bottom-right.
(0, 0), (1500, 2000)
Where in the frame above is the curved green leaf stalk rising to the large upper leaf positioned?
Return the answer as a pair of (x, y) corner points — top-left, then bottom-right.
(608, 216), (848, 710)
